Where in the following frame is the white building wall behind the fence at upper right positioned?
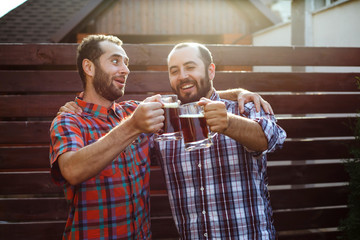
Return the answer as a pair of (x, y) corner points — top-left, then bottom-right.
(253, 0), (360, 72)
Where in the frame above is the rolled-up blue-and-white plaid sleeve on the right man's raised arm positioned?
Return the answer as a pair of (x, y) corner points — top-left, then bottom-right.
(245, 102), (286, 155)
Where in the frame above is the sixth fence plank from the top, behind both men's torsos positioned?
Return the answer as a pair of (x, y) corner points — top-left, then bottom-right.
(0, 163), (348, 196)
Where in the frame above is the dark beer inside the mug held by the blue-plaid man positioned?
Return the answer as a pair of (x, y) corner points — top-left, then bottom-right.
(180, 114), (209, 143)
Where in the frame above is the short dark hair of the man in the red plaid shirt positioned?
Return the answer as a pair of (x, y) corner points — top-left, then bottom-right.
(76, 35), (123, 89)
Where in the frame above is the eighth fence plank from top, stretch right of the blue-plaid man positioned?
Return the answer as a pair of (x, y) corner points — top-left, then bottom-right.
(274, 207), (348, 231)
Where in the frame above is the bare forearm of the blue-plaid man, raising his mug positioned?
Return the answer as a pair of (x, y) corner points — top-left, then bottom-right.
(224, 113), (268, 151)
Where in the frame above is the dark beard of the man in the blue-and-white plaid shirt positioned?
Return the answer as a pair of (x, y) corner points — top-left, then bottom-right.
(171, 73), (212, 104)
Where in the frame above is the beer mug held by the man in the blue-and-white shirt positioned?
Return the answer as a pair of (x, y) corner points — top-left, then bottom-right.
(179, 102), (216, 151)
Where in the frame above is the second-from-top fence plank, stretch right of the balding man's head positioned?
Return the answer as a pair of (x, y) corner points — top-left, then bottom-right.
(214, 72), (360, 92)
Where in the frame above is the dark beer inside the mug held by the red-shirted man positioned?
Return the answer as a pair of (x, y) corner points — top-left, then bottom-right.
(161, 103), (180, 133)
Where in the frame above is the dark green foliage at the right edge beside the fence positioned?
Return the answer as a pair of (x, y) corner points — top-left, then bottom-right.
(339, 77), (360, 240)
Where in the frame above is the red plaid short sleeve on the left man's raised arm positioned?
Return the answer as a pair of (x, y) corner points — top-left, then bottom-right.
(49, 114), (84, 184)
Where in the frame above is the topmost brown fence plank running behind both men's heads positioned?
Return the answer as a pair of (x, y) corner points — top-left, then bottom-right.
(0, 44), (360, 66)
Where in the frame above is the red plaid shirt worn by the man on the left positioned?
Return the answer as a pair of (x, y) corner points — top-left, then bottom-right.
(50, 96), (151, 239)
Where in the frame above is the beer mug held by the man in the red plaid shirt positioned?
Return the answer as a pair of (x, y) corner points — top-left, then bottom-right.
(155, 95), (182, 141)
